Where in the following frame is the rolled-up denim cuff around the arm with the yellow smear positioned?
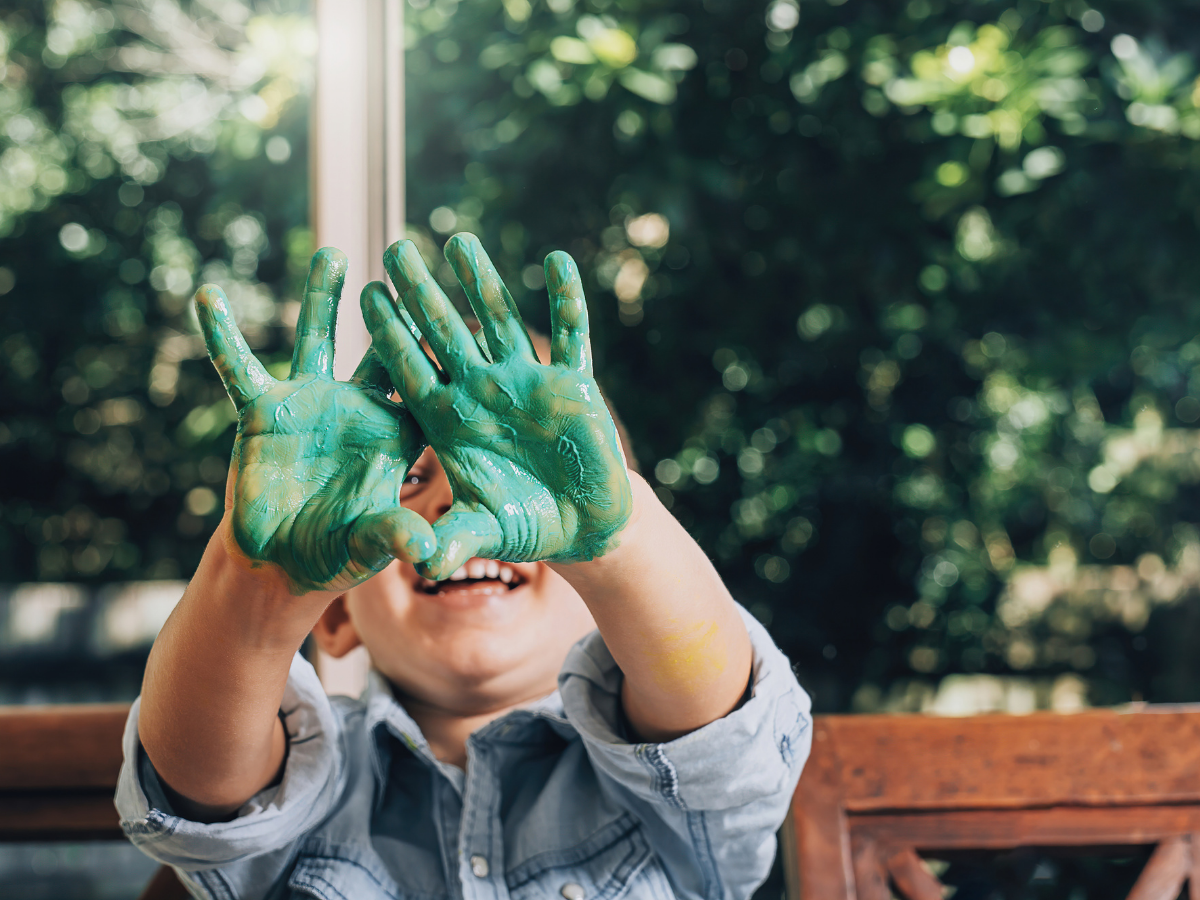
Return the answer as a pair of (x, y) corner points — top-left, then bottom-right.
(559, 606), (812, 810)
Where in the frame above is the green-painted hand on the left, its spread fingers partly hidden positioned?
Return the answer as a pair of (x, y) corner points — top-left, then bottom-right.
(196, 247), (434, 594)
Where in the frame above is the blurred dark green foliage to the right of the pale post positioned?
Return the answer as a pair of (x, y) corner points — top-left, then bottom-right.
(408, 0), (1200, 712)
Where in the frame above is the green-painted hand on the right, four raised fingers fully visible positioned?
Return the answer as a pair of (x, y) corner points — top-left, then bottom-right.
(362, 234), (632, 578)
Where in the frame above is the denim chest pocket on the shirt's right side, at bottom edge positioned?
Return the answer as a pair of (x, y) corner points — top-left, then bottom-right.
(504, 814), (670, 900)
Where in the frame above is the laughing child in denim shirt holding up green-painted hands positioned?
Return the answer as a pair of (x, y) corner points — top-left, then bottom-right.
(116, 235), (810, 900)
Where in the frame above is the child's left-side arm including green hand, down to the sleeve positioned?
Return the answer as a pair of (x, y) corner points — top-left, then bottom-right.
(138, 250), (433, 821)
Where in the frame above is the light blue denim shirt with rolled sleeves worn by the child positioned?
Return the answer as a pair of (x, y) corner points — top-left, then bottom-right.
(116, 611), (811, 900)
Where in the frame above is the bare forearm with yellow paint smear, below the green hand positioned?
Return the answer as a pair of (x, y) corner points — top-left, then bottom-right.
(553, 474), (752, 740)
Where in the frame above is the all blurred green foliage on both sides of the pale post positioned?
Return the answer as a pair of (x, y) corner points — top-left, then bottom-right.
(9, 0), (1200, 724)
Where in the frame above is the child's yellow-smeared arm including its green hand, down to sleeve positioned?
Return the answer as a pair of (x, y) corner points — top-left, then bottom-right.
(362, 235), (751, 740)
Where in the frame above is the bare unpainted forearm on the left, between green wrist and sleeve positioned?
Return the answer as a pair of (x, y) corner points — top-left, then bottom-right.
(138, 516), (334, 820)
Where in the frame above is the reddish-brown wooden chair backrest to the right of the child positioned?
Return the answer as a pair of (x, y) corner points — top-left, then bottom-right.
(785, 704), (1200, 900)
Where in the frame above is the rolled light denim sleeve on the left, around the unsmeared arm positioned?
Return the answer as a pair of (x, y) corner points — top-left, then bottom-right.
(115, 654), (346, 900)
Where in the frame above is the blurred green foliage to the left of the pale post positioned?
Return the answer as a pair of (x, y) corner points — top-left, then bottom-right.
(0, 0), (316, 581)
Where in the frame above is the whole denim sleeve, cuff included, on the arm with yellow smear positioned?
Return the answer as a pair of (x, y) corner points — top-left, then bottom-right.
(559, 607), (812, 900)
